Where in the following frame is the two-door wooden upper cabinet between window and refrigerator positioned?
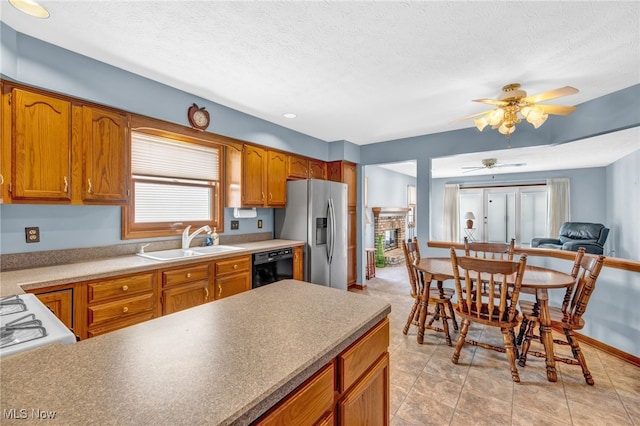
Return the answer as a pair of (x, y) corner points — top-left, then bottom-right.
(225, 144), (287, 207)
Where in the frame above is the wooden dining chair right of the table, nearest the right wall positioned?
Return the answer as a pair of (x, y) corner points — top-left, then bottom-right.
(518, 252), (605, 385)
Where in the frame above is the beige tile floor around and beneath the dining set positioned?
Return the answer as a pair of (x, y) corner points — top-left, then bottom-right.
(350, 264), (640, 426)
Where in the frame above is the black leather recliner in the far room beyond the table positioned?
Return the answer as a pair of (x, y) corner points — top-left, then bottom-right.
(531, 222), (609, 254)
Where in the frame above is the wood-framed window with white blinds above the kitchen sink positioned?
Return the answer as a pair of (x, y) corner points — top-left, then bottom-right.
(127, 131), (221, 237)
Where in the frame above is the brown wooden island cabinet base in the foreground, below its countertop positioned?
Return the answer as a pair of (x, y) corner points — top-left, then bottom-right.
(254, 318), (389, 426)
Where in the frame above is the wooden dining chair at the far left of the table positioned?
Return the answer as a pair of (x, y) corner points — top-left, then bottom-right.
(402, 238), (458, 346)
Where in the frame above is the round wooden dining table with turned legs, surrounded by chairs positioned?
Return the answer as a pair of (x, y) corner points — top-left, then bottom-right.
(414, 257), (575, 382)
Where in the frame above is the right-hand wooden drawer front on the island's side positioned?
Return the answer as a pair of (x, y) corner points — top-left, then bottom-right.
(337, 318), (389, 393)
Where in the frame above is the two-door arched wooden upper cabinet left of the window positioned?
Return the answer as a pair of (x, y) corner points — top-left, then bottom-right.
(2, 83), (129, 204)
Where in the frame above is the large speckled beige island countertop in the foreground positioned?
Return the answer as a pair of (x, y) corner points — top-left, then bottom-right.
(0, 280), (391, 425)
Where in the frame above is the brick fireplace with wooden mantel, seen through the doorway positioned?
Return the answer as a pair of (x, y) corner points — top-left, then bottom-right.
(371, 207), (409, 265)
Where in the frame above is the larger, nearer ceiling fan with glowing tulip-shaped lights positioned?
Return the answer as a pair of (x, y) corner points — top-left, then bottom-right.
(449, 83), (578, 138)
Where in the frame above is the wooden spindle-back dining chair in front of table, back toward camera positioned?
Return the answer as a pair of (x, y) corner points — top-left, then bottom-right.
(451, 247), (527, 382)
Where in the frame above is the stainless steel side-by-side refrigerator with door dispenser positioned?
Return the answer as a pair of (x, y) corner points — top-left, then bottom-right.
(274, 179), (347, 290)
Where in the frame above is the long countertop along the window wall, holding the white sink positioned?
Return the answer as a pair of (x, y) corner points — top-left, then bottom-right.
(0, 239), (304, 297)
